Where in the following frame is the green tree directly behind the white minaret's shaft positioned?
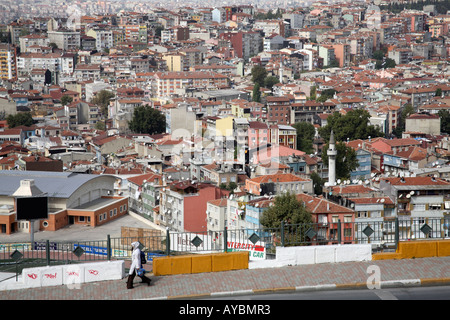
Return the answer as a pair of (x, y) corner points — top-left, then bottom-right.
(322, 142), (359, 179)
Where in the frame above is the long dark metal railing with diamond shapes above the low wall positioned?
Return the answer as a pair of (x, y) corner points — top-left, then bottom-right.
(0, 217), (450, 272)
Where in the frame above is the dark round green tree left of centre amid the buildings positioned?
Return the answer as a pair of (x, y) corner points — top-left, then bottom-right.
(128, 106), (166, 134)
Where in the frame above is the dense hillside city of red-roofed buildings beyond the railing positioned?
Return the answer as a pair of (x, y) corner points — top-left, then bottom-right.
(0, 0), (450, 256)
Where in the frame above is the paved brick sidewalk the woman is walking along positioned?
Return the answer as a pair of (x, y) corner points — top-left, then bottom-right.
(0, 257), (450, 300)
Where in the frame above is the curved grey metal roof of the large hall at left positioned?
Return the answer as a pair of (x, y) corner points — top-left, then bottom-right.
(0, 170), (111, 198)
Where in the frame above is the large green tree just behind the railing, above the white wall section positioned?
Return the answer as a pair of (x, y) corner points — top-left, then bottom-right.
(260, 193), (312, 228)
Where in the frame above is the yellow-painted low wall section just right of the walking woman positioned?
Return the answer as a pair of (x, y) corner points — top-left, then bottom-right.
(153, 251), (249, 276)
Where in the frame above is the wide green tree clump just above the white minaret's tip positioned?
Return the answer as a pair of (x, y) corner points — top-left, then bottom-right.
(319, 109), (384, 141)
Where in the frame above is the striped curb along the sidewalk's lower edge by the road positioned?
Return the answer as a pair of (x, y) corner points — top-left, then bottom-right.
(146, 278), (450, 300)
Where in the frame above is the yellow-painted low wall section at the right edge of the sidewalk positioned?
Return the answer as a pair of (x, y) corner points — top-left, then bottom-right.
(372, 240), (450, 260)
